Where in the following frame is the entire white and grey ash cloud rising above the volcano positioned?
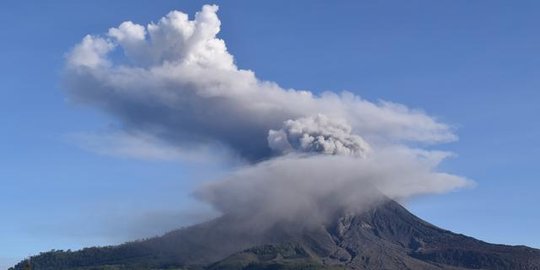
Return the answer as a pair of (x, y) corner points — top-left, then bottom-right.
(63, 5), (470, 228)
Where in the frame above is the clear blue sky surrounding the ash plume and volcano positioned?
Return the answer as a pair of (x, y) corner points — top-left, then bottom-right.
(0, 0), (540, 268)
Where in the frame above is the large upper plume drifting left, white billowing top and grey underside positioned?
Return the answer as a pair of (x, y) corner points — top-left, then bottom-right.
(64, 5), (456, 161)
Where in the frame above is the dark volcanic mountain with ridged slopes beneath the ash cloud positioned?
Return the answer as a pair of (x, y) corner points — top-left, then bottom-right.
(12, 200), (540, 270)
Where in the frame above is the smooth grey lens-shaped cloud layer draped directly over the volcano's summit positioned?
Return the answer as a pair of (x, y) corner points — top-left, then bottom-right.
(196, 151), (469, 228)
